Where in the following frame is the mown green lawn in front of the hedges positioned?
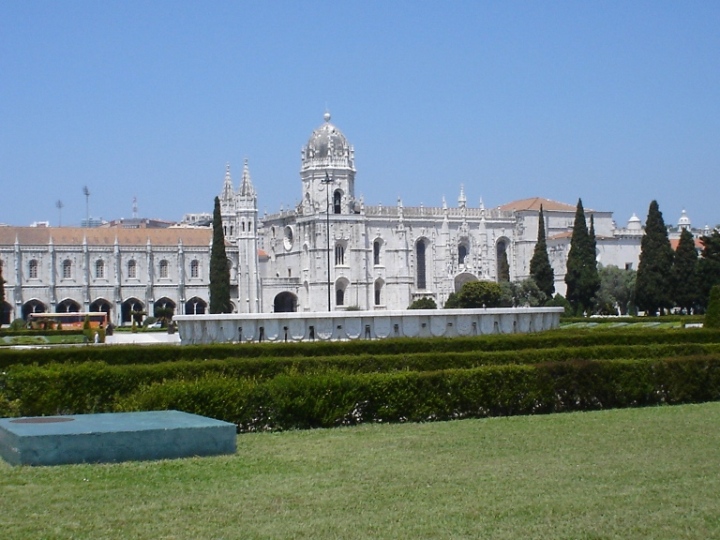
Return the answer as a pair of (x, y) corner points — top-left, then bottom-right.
(0, 403), (720, 540)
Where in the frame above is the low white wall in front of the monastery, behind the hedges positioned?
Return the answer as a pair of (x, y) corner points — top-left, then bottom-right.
(173, 307), (563, 344)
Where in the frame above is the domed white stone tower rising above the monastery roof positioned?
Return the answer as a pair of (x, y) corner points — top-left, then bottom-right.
(300, 113), (355, 214)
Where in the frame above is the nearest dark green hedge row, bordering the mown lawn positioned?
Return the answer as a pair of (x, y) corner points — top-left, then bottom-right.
(118, 355), (720, 432)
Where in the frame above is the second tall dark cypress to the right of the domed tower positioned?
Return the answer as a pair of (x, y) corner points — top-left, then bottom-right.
(565, 199), (600, 315)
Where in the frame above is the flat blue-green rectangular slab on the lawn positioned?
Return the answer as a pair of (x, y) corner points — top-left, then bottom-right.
(0, 411), (237, 465)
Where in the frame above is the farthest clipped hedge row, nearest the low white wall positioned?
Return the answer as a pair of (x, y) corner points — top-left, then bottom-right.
(0, 328), (720, 369)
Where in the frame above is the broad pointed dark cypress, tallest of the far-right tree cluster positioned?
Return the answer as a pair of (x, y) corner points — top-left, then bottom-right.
(635, 201), (673, 315)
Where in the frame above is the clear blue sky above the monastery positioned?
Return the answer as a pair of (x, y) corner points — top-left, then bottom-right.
(0, 0), (720, 226)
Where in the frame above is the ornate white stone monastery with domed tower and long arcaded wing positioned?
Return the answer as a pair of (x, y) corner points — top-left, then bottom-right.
(0, 113), (689, 324)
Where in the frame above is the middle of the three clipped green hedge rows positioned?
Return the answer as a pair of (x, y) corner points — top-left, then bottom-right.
(5, 344), (720, 416)
